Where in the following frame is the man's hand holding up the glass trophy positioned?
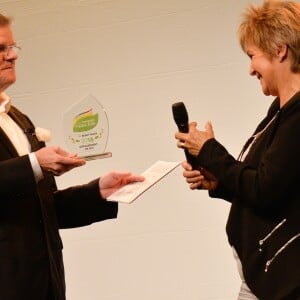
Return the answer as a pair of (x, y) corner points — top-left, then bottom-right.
(35, 146), (85, 176)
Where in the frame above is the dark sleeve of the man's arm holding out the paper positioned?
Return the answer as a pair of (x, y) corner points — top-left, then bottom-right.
(54, 179), (118, 228)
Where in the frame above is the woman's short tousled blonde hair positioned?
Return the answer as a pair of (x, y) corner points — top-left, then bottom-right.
(238, 0), (300, 73)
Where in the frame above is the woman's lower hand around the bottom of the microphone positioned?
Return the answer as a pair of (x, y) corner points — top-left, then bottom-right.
(181, 161), (218, 191)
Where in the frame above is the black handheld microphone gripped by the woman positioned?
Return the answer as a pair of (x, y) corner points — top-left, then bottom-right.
(172, 102), (197, 169)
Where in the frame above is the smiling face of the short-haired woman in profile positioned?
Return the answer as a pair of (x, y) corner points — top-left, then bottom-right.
(246, 45), (278, 96)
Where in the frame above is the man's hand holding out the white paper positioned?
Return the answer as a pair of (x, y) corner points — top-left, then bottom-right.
(99, 172), (145, 199)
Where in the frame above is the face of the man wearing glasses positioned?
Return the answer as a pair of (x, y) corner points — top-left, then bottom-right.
(0, 26), (18, 92)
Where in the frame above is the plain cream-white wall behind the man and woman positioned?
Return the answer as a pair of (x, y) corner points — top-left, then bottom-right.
(0, 0), (271, 300)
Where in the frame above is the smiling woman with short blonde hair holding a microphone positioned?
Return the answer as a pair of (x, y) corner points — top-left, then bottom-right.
(175, 0), (300, 300)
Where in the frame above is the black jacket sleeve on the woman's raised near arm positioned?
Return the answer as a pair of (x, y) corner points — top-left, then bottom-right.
(198, 101), (300, 209)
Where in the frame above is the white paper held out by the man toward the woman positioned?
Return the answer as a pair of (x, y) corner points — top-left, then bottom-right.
(107, 160), (180, 203)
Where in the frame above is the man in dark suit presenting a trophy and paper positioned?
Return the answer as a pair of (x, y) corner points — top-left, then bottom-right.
(0, 15), (143, 300)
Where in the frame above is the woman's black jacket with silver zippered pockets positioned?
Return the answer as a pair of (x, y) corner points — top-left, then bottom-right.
(197, 93), (300, 300)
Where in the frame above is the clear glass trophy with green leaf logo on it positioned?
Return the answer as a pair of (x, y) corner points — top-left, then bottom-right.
(63, 95), (112, 160)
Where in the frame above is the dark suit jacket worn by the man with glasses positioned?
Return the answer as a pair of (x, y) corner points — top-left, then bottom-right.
(0, 107), (118, 300)
